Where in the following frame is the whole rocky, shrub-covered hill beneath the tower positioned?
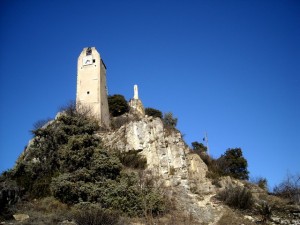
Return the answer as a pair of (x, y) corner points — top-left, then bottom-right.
(0, 100), (300, 225)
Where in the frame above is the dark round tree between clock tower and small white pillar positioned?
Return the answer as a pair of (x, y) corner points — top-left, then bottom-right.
(108, 95), (129, 116)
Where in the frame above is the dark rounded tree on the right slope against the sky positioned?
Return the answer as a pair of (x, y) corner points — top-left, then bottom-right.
(217, 148), (249, 180)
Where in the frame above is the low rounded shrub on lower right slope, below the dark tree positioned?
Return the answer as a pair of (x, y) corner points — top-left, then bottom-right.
(217, 187), (253, 209)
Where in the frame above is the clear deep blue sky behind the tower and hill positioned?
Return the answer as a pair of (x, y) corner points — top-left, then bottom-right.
(0, 0), (300, 189)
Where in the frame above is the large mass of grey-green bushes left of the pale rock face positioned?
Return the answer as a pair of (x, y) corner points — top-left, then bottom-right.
(6, 104), (165, 216)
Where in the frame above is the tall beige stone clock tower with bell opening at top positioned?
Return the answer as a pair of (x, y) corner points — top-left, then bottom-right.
(76, 47), (110, 128)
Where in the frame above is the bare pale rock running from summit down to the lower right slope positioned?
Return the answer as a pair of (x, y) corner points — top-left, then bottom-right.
(98, 116), (222, 223)
